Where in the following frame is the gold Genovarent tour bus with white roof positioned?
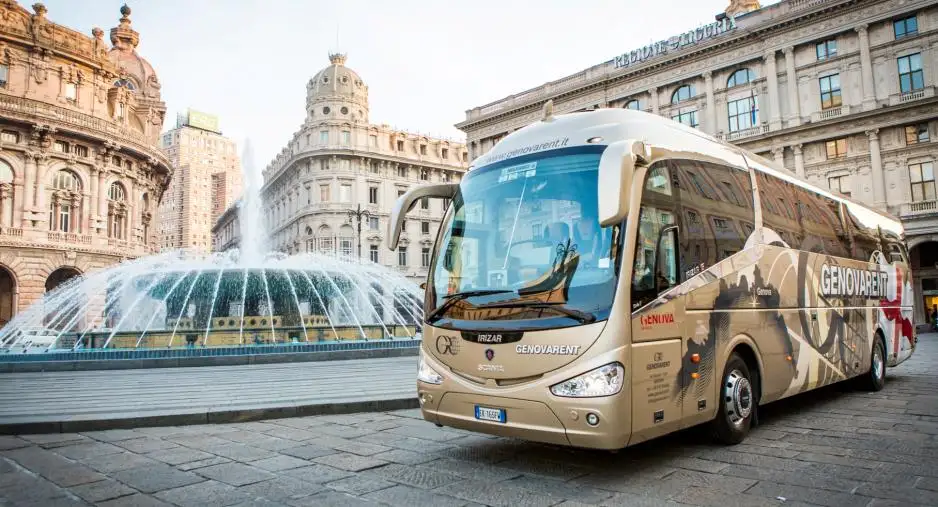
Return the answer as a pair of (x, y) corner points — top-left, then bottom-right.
(388, 106), (916, 450)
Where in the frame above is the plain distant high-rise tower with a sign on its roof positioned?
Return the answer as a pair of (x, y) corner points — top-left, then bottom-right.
(159, 111), (243, 252)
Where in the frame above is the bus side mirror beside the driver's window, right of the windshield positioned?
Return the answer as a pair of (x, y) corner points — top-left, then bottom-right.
(597, 139), (650, 227)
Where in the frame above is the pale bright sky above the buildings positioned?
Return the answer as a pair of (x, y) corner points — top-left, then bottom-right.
(38, 0), (777, 170)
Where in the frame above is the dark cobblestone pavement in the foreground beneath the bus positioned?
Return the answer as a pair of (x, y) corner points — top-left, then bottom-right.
(0, 334), (938, 507)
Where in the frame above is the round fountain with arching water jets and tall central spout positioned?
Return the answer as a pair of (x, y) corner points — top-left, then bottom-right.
(0, 142), (422, 353)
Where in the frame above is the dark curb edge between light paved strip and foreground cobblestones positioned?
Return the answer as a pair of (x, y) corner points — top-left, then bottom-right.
(0, 397), (420, 435)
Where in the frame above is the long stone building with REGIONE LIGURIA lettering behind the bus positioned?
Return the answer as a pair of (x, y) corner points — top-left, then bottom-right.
(457, 0), (938, 323)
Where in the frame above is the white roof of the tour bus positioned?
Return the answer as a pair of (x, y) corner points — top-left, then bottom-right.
(469, 108), (903, 236)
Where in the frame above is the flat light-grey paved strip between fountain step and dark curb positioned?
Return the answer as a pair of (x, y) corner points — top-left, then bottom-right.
(0, 357), (418, 437)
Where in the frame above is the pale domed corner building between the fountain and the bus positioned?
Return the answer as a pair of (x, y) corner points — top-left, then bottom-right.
(261, 54), (468, 286)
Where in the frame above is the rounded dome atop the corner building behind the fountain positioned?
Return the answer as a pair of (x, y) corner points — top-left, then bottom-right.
(306, 53), (368, 123)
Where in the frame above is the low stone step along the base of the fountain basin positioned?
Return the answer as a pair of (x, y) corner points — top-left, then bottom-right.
(0, 347), (417, 373)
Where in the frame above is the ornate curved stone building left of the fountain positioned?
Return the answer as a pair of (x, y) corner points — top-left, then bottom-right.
(0, 0), (171, 325)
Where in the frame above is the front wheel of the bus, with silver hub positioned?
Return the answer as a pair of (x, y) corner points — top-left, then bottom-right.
(711, 352), (756, 445)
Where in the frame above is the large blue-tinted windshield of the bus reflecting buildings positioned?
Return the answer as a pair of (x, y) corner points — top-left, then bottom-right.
(426, 146), (619, 330)
